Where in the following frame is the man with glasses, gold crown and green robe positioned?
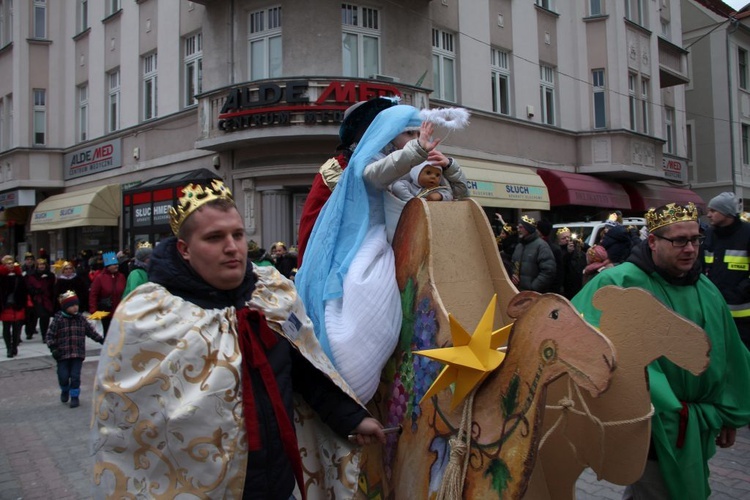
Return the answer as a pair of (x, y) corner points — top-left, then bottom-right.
(572, 203), (750, 499)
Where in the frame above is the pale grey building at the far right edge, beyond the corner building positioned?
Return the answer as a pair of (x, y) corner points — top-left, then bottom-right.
(682, 0), (750, 207)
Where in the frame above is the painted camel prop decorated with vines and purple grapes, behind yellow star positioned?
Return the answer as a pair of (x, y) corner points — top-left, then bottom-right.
(358, 199), (614, 498)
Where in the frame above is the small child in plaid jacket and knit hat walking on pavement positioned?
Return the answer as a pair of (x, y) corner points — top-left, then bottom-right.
(47, 290), (104, 408)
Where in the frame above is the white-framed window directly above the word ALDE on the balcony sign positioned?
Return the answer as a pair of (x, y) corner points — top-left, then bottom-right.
(247, 6), (283, 80)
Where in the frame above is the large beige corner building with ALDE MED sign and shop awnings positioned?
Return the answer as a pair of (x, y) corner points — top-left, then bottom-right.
(0, 0), (699, 257)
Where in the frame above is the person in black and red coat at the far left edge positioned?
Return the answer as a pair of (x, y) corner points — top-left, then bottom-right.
(0, 255), (29, 358)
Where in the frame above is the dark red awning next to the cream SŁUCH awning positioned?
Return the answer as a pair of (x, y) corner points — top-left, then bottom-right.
(536, 169), (630, 210)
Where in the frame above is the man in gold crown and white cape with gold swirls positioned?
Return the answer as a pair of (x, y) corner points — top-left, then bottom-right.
(92, 181), (385, 499)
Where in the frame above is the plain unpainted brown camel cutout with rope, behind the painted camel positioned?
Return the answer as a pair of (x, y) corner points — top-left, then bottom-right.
(532, 286), (711, 500)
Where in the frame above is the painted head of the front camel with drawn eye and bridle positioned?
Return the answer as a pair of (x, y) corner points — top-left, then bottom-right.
(506, 291), (615, 396)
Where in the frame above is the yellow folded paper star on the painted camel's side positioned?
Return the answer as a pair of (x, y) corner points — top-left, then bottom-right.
(414, 295), (512, 409)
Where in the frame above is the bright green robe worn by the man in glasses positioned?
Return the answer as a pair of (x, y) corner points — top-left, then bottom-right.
(572, 262), (750, 499)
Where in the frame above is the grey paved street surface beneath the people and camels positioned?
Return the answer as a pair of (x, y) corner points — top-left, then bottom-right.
(0, 335), (750, 500)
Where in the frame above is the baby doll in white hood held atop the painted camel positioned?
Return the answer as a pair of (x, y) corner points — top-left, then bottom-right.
(390, 158), (469, 201)
